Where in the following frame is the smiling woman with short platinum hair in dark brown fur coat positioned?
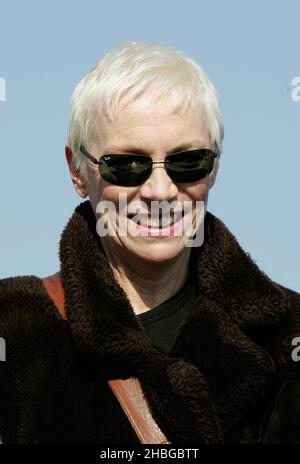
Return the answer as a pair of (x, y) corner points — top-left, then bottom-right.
(0, 42), (300, 445)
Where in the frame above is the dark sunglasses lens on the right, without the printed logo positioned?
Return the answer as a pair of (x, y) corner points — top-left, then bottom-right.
(166, 149), (215, 182)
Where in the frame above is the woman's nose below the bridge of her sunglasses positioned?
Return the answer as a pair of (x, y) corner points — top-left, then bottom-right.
(140, 164), (178, 201)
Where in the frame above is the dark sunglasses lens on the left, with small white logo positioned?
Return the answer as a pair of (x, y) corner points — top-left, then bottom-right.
(99, 155), (151, 187)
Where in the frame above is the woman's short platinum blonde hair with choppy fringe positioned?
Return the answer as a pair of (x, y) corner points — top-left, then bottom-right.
(68, 42), (224, 176)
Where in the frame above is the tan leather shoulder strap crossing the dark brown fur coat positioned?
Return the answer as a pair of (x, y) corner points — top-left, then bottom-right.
(42, 272), (171, 444)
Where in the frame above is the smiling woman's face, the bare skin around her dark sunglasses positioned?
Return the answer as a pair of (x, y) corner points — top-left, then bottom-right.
(69, 95), (217, 263)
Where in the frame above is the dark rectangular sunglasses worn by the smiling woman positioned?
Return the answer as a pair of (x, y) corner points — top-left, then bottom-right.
(80, 145), (218, 187)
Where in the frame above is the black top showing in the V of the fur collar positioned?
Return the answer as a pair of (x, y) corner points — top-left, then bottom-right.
(137, 277), (197, 354)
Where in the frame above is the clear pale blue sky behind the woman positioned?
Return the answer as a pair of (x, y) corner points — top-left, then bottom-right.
(0, 0), (300, 291)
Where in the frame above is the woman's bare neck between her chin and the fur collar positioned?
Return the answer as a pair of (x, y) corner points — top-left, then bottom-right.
(99, 244), (191, 314)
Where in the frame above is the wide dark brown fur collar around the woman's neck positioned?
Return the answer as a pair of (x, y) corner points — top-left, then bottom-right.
(59, 201), (290, 444)
